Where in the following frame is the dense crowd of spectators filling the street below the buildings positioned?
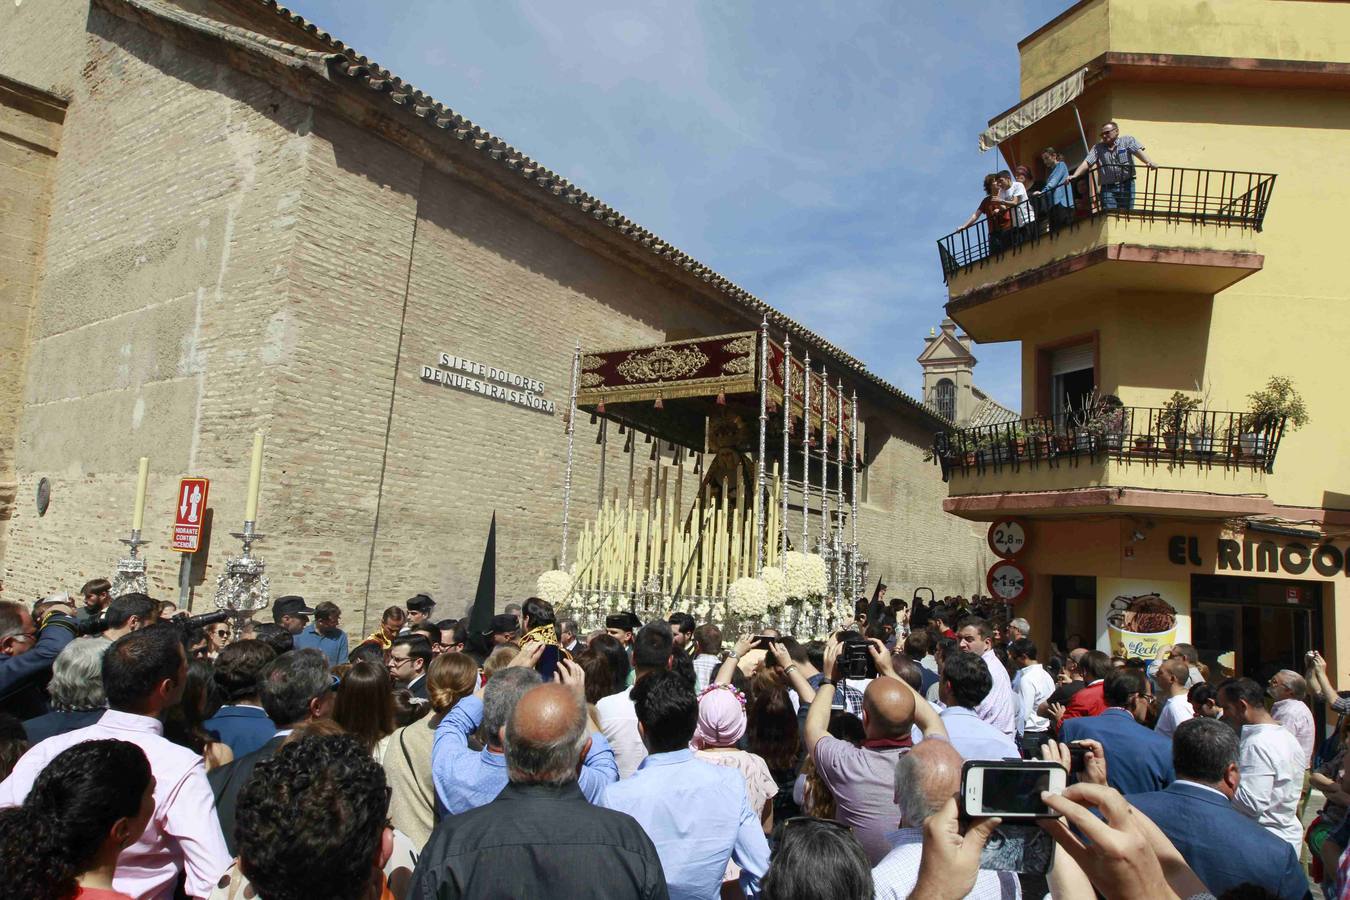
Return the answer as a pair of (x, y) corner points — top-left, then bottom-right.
(0, 580), (1333, 900)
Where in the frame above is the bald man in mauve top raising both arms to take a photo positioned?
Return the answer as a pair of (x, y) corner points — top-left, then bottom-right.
(806, 638), (946, 865)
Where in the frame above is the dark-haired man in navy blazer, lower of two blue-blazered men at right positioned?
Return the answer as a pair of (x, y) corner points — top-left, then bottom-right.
(1128, 719), (1310, 900)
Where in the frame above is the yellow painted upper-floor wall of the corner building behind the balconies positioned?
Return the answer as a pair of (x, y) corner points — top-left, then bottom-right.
(972, 78), (1350, 509)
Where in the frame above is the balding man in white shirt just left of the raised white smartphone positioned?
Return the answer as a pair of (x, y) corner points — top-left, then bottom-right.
(872, 741), (1022, 900)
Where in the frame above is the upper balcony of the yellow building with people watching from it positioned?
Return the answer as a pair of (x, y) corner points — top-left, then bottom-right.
(937, 166), (1276, 341)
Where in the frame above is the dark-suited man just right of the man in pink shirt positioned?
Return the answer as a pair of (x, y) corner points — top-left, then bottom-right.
(207, 649), (338, 854)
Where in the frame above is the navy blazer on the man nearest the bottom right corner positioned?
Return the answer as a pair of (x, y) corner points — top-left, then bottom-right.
(1128, 782), (1312, 900)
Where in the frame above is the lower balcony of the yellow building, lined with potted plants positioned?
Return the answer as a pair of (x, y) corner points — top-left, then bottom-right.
(933, 406), (1285, 518)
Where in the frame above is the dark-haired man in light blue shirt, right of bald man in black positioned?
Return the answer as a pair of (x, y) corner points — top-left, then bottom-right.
(599, 672), (768, 900)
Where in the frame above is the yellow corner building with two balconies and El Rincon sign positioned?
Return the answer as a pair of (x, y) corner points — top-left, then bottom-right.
(936, 0), (1350, 687)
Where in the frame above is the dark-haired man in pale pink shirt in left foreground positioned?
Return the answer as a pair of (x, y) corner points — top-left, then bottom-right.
(0, 625), (231, 900)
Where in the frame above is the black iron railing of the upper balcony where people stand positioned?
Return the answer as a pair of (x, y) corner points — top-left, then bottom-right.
(937, 166), (1274, 281)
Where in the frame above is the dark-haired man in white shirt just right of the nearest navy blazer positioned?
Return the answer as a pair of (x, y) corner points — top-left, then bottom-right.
(1219, 679), (1308, 851)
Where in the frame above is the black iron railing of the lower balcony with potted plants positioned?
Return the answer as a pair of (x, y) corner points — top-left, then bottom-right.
(933, 406), (1285, 482)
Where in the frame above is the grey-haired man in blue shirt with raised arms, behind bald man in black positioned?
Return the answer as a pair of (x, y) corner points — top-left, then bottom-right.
(431, 644), (618, 815)
